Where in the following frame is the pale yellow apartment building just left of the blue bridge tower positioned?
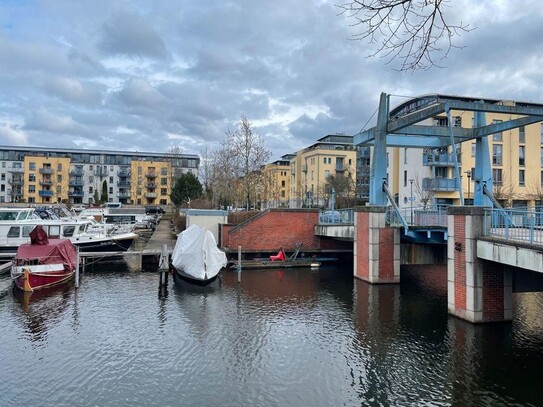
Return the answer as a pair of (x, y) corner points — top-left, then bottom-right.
(289, 134), (356, 208)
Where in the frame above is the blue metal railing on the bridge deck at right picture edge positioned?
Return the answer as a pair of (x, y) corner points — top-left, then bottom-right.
(483, 207), (543, 244)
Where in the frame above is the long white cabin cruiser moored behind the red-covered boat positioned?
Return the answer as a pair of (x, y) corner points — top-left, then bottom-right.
(0, 208), (138, 253)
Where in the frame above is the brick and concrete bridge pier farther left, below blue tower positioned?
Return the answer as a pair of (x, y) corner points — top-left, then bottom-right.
(353, 206), (400, 284)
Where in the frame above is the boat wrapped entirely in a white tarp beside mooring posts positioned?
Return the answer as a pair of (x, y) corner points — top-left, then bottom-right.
(172, 225), (227, 283)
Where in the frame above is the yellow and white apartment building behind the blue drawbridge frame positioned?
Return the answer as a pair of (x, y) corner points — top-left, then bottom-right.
(357, 96), (543, 207)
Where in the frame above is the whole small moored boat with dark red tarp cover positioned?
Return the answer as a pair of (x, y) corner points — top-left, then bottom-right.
(11, 225), (77, 291)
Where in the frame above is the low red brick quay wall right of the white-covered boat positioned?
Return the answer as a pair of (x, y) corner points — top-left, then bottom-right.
(222, 209), (320, 251)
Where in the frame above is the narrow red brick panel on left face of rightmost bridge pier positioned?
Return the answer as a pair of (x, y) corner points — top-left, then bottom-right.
(454, 215), (466, 311)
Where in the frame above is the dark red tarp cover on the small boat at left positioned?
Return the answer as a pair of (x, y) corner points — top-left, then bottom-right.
(15, 226), (77, 271)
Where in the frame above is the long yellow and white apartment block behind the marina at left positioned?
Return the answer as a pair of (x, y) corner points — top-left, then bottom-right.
(0, 146), (200, 205)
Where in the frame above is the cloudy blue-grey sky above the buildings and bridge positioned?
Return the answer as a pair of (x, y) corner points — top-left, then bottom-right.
(0, 0), (543, 160)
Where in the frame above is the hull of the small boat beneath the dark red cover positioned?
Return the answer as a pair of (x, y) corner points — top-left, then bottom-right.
(12, 264), (75, 291)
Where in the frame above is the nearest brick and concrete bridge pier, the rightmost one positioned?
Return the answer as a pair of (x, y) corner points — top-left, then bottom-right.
(447, 206), (513, 323)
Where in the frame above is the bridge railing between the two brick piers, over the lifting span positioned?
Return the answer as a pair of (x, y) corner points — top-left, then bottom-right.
(386, 205), (447, 227)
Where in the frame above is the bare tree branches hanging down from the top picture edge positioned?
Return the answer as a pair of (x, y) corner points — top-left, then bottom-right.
(337, 0), (473, 71)
